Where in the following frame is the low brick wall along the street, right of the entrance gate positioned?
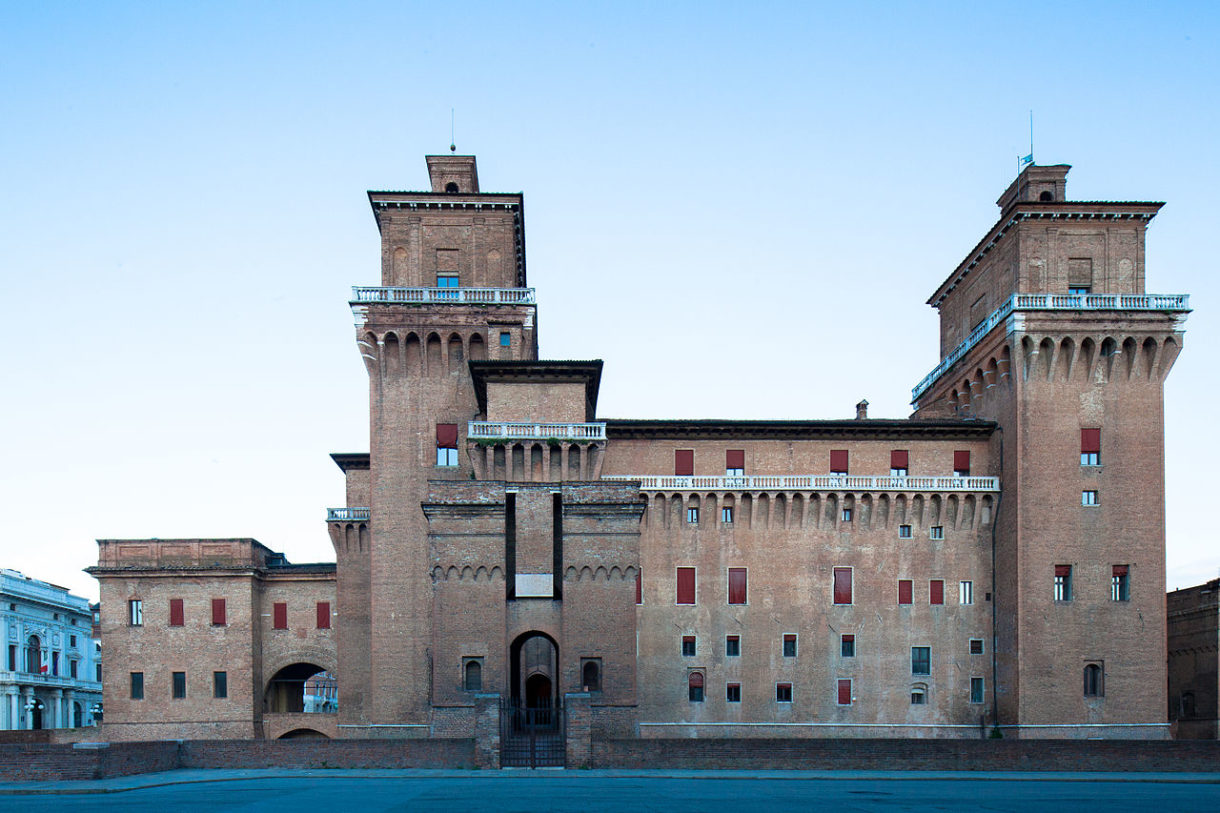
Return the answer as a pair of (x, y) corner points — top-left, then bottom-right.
(593, 739), (1220, 771)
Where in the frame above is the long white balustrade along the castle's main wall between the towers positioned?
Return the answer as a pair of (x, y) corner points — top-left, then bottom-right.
(601, 475), (999, 491)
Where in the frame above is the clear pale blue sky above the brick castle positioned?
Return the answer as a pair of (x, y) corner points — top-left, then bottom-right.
(0, 1), (1220, 597)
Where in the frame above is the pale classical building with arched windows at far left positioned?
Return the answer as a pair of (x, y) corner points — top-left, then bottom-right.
(0, 569), (102, 730)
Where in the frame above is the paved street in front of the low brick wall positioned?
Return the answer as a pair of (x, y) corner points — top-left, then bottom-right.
(0, 771), (1220, 813)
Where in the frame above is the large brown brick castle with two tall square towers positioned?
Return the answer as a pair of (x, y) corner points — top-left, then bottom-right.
(90, 155), (1188, 747)
